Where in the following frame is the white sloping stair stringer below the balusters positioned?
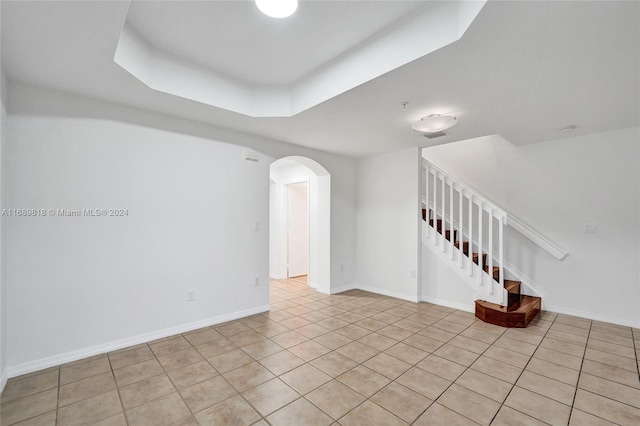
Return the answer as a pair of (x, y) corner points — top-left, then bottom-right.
(422, 222), (507, 305)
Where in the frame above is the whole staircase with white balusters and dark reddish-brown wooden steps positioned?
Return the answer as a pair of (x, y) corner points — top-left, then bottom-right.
(422, 160), (542, 327)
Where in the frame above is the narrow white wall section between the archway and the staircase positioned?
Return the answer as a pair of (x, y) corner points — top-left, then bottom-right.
(357, 148), (421, 301)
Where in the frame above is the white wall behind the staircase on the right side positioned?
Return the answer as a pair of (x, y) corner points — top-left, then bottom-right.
(423, 128), (640, 326)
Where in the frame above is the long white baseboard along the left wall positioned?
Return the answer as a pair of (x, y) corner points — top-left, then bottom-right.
(3, 305), (271, 377)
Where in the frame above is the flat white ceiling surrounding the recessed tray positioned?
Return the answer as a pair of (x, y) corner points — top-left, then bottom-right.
(0, 0), (640, 157)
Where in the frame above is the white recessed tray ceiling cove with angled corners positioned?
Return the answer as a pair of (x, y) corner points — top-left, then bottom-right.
(114, 1), (486, 117)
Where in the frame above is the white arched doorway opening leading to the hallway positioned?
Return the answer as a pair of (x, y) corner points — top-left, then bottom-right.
(269, 156), (331, 294)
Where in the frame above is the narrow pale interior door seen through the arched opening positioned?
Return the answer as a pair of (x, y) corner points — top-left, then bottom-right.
(287, 182), (309, 277)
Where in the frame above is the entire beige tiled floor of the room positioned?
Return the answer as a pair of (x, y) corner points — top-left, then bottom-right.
(0, 281), (640, 426)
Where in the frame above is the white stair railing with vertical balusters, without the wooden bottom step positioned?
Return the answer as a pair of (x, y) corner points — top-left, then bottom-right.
(423, 160), (508, 304)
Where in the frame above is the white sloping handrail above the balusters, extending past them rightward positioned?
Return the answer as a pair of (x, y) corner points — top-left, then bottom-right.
(422, 157), (569, 261)
